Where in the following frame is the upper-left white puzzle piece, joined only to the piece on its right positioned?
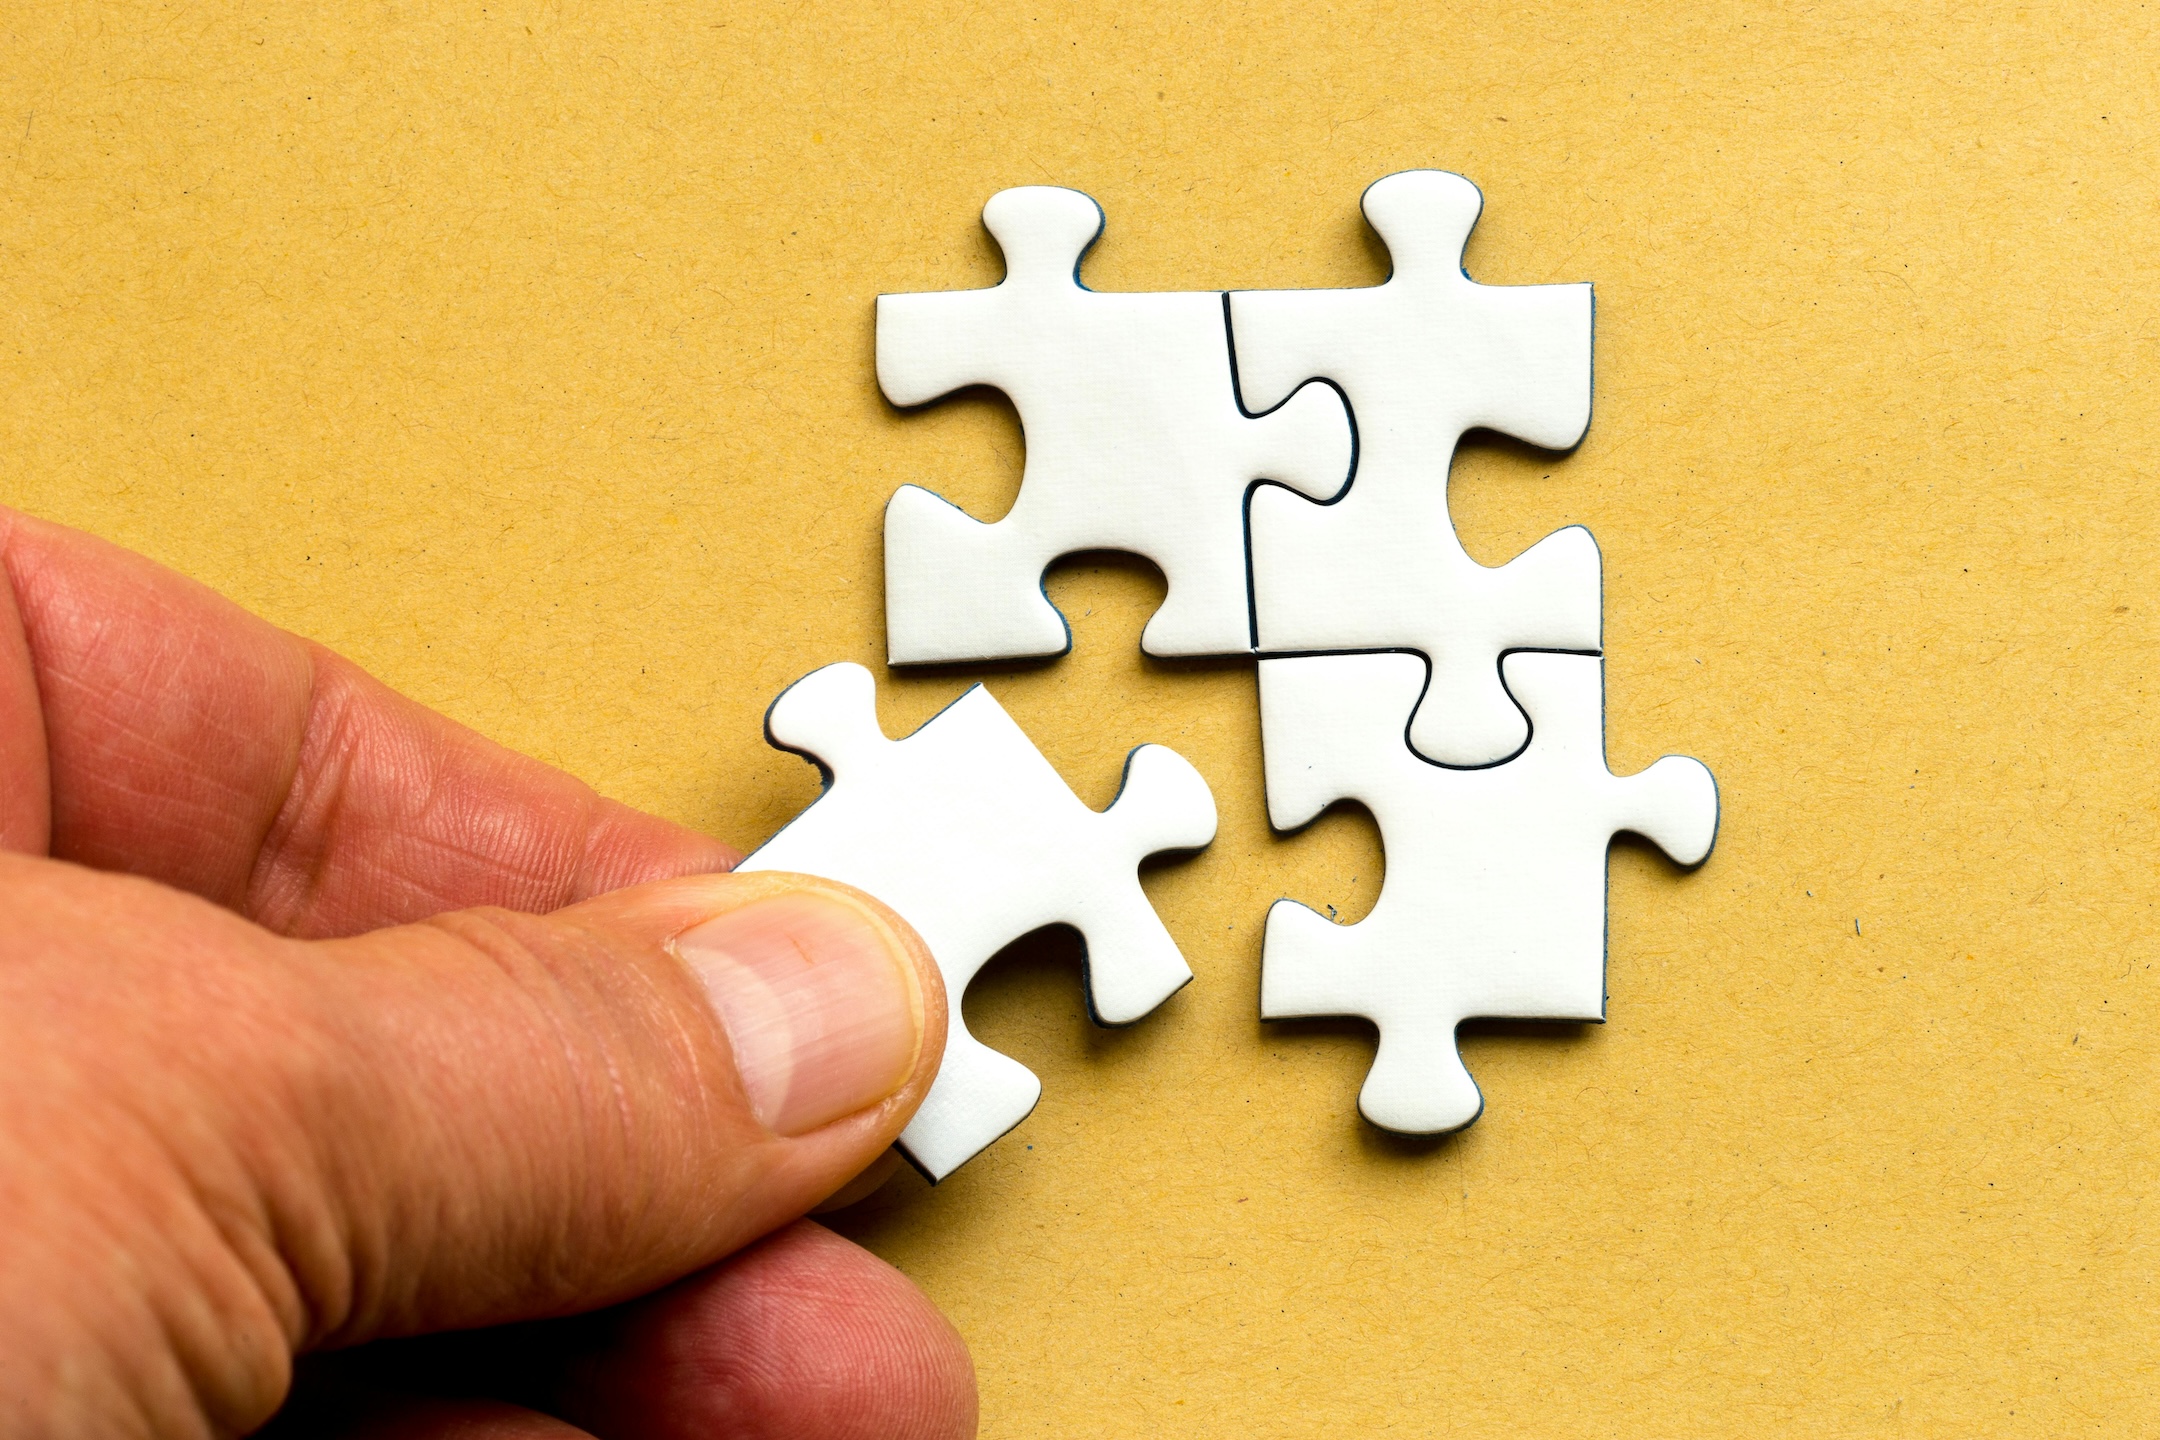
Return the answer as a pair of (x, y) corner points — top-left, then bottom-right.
(877, 186), (1350, 665)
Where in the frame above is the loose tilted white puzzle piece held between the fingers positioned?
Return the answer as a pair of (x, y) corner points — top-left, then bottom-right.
(739, 665), (1216, 1181)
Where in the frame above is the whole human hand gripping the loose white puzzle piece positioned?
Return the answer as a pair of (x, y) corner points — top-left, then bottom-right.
(0, 510), (976, 1440)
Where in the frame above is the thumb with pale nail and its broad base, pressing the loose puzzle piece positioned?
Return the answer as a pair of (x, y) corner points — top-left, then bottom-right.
(0, 855), (946, 1434)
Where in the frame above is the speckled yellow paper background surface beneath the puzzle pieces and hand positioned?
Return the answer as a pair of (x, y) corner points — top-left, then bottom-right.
(0, 0), (2160, 1438)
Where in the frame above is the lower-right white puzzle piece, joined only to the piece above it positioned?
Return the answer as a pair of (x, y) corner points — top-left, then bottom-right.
(1259, 652), (1717, 1136)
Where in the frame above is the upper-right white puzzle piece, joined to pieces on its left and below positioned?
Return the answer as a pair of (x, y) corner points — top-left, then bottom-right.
(1229, 171), (1601, 766)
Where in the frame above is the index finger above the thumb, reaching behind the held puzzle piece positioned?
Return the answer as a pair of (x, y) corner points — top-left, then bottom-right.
(0, 507), (741, 937)
